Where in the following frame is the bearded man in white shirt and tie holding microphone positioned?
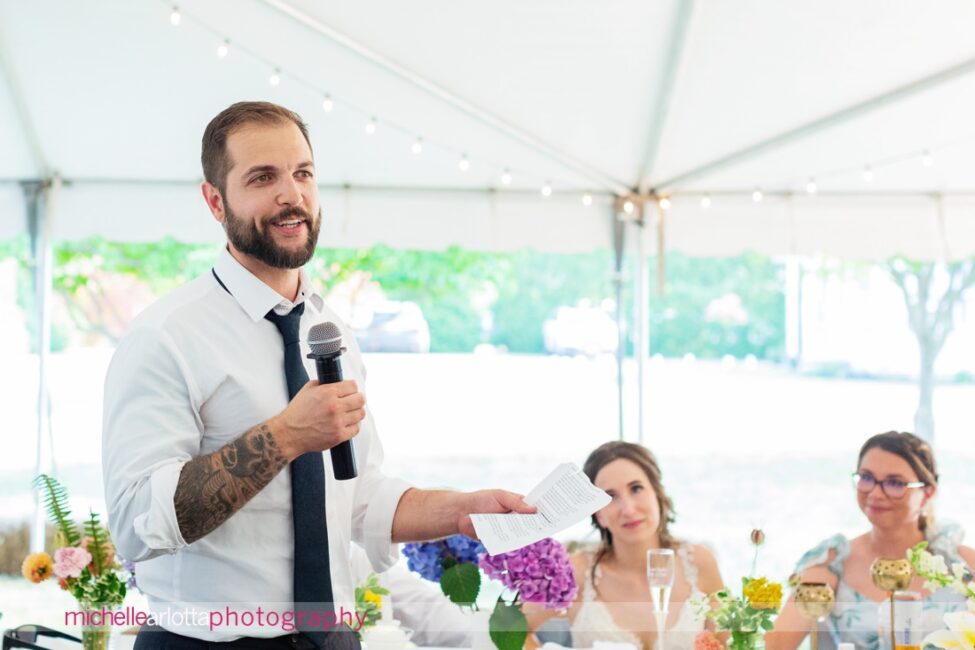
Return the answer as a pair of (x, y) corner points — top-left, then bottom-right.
(103, 102), (534, 650)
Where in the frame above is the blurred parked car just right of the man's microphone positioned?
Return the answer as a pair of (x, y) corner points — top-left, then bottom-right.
(352, 300), (430, 352)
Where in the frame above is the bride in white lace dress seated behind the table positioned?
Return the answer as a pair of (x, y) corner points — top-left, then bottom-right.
(524, 442), (723, 650)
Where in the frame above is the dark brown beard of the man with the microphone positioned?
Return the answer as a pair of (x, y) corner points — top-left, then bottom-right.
(224, 201), (322, 269)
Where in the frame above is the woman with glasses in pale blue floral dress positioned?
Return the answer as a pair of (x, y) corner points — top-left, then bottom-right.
(765, 431), (975, 650)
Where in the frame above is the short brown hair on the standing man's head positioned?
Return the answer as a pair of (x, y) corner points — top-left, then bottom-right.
(200, 102), (311, 197)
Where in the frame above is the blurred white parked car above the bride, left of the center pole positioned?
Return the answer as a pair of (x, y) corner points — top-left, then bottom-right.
(542, 303), (619, 357)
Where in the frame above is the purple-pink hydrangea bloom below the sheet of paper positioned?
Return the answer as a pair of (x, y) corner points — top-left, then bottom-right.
(481, 537), (577, 609)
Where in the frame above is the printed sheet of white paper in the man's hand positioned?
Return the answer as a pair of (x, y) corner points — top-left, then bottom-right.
(471, 463), (611, 555)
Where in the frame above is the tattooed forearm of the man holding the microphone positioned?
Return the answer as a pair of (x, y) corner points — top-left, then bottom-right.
(174, 423), (288, 543)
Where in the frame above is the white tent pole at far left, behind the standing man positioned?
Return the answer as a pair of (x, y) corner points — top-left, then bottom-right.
(21, 179), (60, 553)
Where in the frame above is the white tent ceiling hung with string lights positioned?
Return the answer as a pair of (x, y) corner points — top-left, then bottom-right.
(0, 0), (975, 258)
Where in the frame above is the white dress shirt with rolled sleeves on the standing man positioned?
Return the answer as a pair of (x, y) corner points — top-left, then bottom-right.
(102, 249), (409, 641)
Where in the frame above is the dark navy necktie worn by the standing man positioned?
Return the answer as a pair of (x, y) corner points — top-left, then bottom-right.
(265, 303), (334, 646)
